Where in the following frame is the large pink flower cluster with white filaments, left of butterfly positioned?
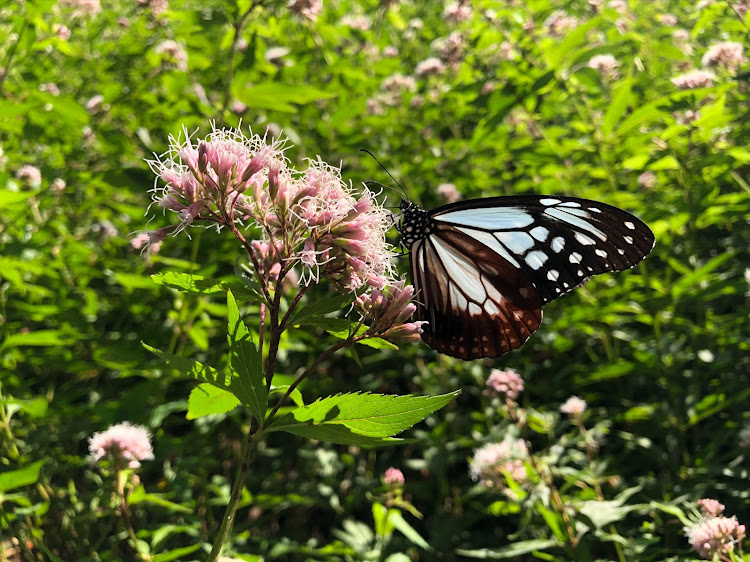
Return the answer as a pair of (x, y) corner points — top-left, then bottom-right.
(149, 128), (400, 291)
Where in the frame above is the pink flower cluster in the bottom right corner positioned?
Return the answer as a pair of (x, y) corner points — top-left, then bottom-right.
(685, 498), (745, 560)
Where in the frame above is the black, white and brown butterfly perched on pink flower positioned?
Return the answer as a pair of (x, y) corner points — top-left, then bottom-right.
(397, 195), (654, 359)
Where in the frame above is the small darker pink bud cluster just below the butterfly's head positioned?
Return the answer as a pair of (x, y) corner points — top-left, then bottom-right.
(356, 280), (424, 343)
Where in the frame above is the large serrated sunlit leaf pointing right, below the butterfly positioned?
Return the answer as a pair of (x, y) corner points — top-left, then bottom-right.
(269, 391), (459, 443)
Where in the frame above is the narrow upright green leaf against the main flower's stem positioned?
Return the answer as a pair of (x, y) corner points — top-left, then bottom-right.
(227, 291), (268, 423)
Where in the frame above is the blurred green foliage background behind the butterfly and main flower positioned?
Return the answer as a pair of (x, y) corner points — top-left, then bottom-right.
(0, 0), (750, 560)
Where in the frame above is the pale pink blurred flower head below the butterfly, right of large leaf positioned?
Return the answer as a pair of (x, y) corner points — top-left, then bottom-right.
(469, 437), (529, 488)
